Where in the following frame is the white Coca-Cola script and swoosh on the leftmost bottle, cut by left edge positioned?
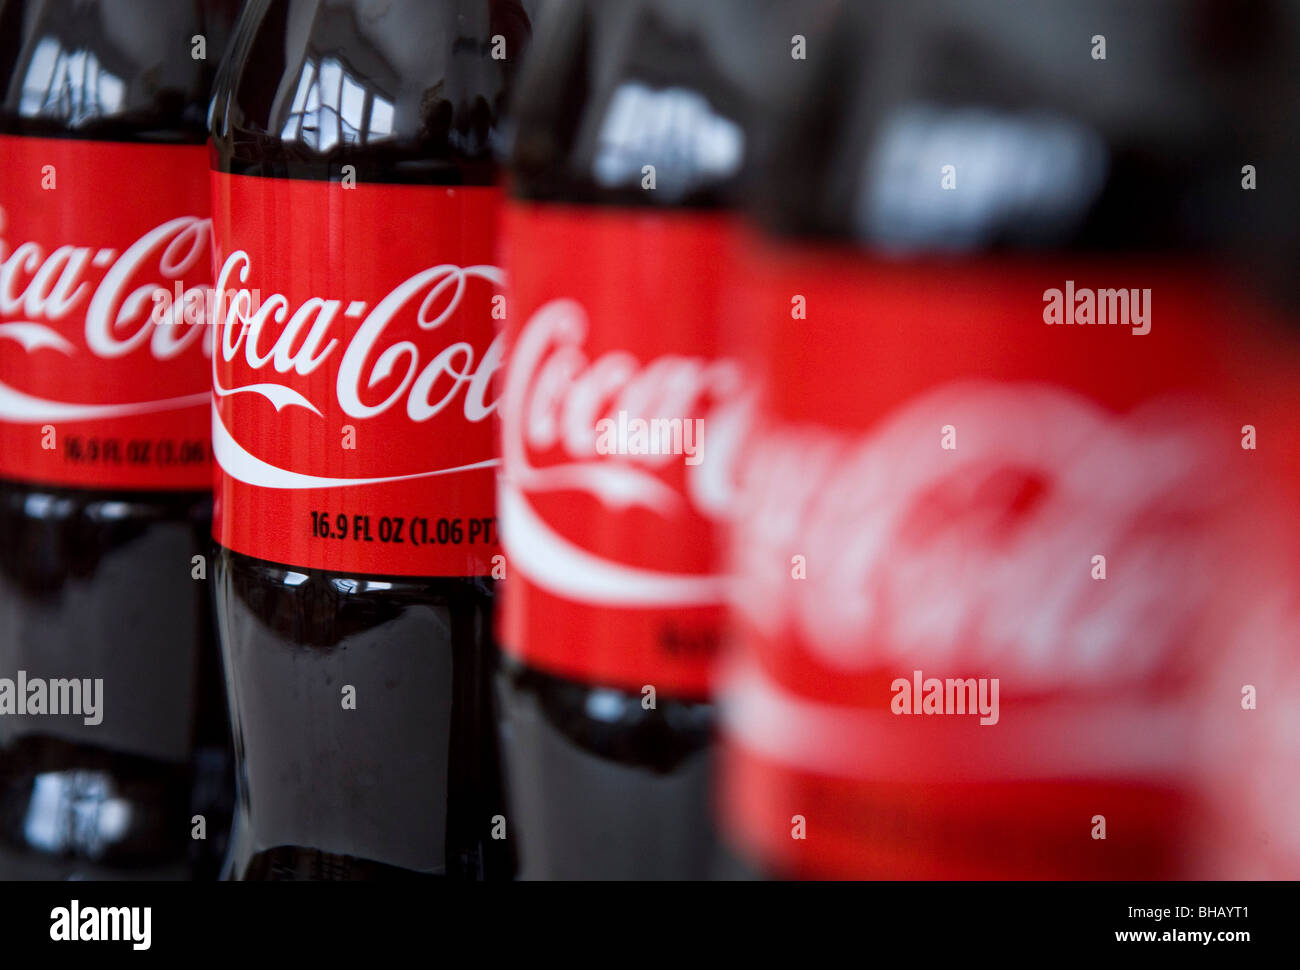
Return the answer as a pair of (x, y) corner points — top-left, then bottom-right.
(0, 208), (212, 423)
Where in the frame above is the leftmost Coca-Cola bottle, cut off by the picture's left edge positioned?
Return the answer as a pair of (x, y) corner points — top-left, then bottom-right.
(0, 0), (234, 878)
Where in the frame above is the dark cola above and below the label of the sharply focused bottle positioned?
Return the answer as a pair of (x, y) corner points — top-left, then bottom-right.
(212, 0), (537, 879)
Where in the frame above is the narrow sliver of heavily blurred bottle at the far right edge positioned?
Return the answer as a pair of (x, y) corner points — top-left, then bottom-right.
(1197, 3), (1300, 880)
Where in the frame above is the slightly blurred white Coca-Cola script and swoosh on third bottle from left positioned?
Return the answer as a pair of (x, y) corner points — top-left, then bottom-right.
(498, 299), (753, 606)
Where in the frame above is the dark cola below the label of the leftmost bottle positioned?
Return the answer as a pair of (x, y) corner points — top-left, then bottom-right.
(0, 482), (219, 878)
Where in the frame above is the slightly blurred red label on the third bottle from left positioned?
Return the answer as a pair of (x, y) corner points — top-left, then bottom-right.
(501, 203), (750, 697)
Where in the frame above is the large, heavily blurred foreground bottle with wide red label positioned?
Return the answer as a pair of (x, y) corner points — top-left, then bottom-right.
(723, 0), (1300, 879)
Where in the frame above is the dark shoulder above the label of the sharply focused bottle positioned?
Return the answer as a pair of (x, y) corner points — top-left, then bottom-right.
(209, 0), (536, 185)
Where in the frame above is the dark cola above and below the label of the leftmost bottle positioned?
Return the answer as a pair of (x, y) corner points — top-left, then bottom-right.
(0, 0), (234, 879)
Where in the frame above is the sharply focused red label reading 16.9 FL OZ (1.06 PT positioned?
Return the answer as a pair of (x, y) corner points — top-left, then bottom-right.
(212, 173), (503, 576)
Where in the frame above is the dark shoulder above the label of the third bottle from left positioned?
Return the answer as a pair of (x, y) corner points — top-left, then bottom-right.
(506, 0), (780, 209)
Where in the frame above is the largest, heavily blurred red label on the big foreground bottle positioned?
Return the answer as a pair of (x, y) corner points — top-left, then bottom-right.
(724, 240), (1294, 878)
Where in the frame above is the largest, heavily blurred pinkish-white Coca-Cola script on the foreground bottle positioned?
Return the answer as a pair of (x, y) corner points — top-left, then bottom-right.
(733, 382), (1232, 689)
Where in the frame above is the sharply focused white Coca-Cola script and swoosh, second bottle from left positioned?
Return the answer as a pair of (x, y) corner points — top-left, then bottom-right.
(212, 250), (502, 489)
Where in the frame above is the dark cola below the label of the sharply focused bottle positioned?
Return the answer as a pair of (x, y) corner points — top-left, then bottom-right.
(216, 549), (510, 879)
